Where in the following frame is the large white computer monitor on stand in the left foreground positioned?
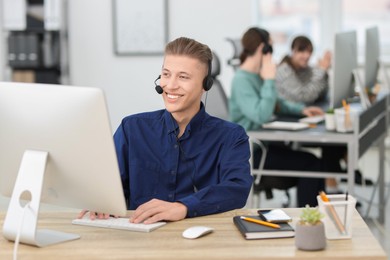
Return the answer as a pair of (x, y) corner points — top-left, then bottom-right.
(0, 82), (126, 246)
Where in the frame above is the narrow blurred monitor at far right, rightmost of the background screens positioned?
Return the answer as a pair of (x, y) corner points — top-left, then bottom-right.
(364, 26), (380, 88)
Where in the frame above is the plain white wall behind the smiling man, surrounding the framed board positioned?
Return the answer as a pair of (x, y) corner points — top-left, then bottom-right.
(69, 0), (251, 129)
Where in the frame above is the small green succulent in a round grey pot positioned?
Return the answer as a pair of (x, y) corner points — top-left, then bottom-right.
(295, 205), (326, 251)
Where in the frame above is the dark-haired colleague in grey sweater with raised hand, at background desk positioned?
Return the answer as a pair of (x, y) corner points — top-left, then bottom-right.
(275, 35), (372, 189)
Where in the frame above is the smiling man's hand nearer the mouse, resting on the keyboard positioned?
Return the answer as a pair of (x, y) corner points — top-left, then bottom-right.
(130, 199), (187, 224)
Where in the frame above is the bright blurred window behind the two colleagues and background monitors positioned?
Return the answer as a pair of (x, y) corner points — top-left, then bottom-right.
(252, 0), (390, 63)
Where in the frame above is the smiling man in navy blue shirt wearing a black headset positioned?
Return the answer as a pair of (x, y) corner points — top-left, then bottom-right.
(114, 37), (252, 224)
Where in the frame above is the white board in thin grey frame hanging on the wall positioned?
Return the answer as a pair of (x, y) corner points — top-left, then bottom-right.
(113, 0), (168, 55)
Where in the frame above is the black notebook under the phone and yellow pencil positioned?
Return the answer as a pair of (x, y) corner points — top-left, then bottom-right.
(233, 216), (295, 239)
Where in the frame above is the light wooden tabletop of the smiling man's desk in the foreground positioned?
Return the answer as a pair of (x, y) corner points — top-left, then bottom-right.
(0, 209), (387, 260)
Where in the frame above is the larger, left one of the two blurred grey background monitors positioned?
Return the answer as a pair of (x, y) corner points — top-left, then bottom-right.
(330, 31), (357, 108)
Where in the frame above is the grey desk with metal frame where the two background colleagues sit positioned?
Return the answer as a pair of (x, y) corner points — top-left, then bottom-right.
(247, 94), (390, 224)
